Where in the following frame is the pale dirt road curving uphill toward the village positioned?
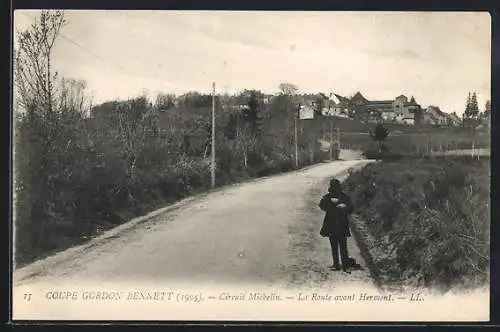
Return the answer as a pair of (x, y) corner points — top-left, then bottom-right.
(14, 154), (376, 287)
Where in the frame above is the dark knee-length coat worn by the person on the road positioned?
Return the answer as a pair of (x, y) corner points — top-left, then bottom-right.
(319, 192), (354, 238)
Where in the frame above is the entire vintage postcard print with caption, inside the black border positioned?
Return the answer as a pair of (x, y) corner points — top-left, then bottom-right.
(11, 9), (492, 322)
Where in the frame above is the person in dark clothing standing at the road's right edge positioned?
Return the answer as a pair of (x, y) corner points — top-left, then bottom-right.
(319, 179), (354, 273)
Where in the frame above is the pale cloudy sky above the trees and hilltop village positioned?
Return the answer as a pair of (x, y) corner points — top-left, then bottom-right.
(14, 10), (491, 114)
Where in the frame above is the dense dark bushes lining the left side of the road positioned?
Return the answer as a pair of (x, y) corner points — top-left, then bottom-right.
(15, 94), (332, 265)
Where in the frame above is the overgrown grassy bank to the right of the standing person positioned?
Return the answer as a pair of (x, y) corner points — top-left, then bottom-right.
(345, 157), (490, 290)
